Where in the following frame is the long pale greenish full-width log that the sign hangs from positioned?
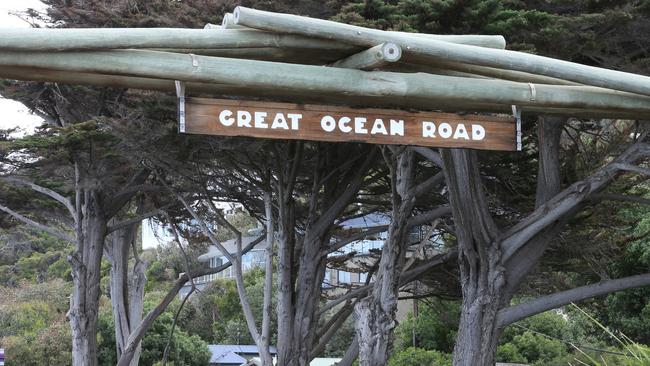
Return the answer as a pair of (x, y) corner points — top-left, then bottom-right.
(0, 50), (650, 113)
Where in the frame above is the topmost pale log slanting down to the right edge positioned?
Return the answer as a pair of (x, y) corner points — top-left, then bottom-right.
(234, 6), (650, 95)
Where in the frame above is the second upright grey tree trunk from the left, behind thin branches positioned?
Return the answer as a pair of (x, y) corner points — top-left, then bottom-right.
(106, 220), (146, 366)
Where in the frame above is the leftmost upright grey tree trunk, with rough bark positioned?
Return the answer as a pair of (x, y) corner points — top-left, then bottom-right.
(68, 206), (106, 366)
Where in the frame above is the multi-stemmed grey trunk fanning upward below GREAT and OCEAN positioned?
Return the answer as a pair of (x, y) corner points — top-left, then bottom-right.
(275, 144), (375, 366)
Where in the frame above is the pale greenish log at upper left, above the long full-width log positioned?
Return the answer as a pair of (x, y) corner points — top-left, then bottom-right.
(0, 28), (363, 54)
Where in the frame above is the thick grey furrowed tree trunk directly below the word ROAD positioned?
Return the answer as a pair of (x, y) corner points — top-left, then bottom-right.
(441, 149), (509, 366)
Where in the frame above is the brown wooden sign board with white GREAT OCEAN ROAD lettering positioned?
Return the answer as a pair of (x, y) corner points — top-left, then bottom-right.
(180, 98), (520, 151)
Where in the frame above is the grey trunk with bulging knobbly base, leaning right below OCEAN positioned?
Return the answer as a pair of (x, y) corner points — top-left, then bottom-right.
(355, 149), (415, 366)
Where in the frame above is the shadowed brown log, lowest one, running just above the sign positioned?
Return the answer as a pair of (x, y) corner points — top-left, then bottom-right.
(0, 66), (650, 119)
